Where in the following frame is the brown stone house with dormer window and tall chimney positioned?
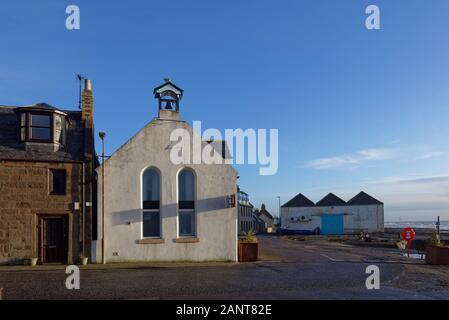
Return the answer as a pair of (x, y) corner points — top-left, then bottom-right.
(0, 80), (98, 264)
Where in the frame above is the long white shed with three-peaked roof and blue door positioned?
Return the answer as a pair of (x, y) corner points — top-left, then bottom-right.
(281, 191), (384, 235)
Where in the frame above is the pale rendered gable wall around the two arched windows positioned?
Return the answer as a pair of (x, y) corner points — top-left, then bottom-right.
(97, 115), (238, 262)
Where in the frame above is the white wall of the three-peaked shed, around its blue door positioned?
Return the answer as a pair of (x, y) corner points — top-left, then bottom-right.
(281, 205), (384, 233)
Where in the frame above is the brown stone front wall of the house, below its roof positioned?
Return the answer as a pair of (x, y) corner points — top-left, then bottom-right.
(0, 161), (82, 263)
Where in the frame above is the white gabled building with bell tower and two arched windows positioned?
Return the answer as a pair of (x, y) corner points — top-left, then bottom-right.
(94, 79), (238, 262)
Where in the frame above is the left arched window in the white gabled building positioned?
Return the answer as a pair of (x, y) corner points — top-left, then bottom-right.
(142, 169), (161, 238)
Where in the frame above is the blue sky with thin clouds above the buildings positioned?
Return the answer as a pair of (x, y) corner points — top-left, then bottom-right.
(0, 0), (449, 220)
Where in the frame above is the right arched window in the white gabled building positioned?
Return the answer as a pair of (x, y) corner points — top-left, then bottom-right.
(178, 169), (196, 237)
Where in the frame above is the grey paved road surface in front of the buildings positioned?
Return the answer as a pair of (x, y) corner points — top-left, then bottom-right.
(0, 236), (449, 300)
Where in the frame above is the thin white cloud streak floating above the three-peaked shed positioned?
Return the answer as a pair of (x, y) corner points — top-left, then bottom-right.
(306, 149), (395, 170)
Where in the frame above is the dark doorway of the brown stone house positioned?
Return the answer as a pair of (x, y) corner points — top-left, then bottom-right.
(39, 215), (67, 263)
